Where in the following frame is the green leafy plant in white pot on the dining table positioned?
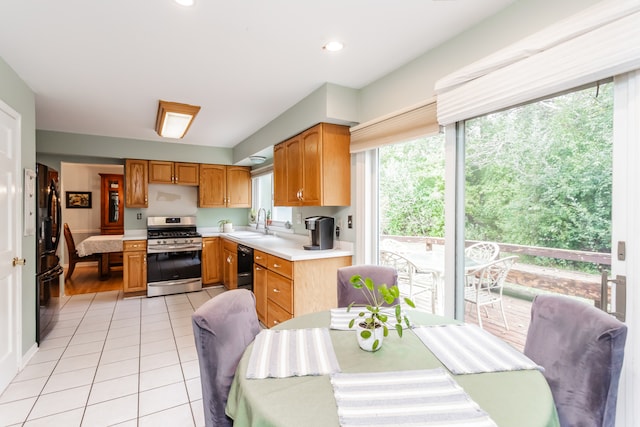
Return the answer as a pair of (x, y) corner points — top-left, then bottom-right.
(347, 274), (416, 351)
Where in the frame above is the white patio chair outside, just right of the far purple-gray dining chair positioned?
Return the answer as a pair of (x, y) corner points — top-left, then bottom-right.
(380, 250), (436, 313)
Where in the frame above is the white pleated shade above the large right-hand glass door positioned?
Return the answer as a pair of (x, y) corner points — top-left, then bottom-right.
(435, 0), (640, 125)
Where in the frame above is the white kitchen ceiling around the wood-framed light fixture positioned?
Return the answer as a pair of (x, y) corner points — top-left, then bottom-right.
(0, 0), (513, 153)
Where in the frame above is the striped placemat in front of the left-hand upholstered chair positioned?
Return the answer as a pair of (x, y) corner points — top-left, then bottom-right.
(246, 328), (340, 379)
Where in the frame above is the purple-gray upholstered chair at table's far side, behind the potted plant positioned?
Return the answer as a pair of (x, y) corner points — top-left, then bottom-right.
(338, 265), (398, 307)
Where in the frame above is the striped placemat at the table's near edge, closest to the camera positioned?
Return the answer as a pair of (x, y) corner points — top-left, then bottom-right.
(331, 368), (496, 427)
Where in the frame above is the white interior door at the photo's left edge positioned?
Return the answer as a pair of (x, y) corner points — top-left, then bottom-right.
(0, 101), (22, 393)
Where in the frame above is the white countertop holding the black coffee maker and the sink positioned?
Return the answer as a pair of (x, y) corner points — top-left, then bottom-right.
(198, 229), (353, 261)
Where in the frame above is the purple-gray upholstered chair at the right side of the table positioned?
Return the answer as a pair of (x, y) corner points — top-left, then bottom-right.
(524, 295), (627, 427)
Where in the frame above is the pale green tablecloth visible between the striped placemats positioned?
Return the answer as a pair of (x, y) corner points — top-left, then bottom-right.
(227, 311), (560, 427)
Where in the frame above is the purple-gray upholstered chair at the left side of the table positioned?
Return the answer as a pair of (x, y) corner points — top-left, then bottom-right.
(191, 289), (260, 427)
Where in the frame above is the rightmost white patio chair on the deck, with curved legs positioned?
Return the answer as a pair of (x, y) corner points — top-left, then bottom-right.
(464, 256), (518, 331)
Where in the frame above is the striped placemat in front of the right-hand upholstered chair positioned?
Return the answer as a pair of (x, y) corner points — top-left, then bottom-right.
(413, 324), (542, 374)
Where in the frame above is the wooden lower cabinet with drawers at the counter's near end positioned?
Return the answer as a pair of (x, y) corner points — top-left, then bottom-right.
(253, 251), (351, 328)
